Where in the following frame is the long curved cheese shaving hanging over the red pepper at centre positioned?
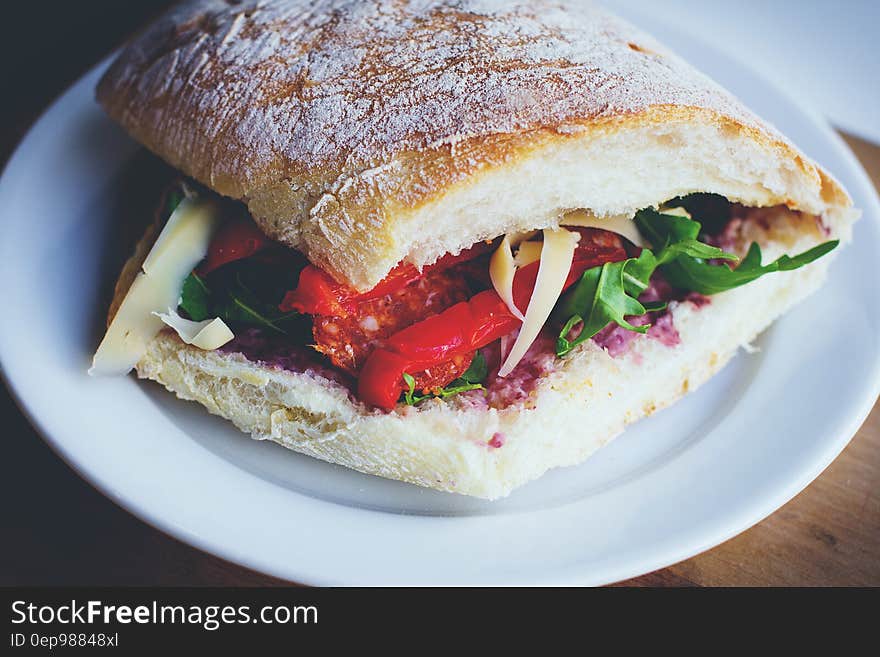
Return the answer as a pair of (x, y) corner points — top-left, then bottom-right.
(498, 228), (580, 377)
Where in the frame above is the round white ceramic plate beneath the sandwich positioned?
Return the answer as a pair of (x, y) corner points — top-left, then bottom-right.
(0, 14), (880, 584)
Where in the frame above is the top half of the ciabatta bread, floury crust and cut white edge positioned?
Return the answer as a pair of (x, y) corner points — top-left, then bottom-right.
(98, 0), (848, 289)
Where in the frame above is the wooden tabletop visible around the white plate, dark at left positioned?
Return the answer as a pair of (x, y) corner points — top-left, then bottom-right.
(0, 0), (880, 586)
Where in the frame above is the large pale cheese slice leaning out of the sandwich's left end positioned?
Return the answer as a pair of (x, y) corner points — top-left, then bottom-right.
(89, 198), (218, 375)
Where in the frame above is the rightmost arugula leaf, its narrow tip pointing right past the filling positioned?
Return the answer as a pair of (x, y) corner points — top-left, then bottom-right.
(663, 240), (840, 295)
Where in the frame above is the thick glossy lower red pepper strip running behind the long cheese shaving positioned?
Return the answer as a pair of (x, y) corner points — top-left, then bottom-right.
(358, 228), (627, 410)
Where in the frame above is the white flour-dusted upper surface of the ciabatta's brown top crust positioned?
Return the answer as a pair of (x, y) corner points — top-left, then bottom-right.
(103, 0), (776, 195)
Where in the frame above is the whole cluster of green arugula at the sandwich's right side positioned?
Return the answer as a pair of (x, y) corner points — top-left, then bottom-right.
(554, 206), (839, 356)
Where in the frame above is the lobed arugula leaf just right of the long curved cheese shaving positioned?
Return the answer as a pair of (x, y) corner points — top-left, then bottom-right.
(556, 258), (653, 356)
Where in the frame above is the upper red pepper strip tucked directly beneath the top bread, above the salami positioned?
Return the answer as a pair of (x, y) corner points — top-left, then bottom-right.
(279, 242), (492, 317)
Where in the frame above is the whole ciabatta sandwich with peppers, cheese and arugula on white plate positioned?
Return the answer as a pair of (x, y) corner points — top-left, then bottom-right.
(91, 0), (858, 499)
